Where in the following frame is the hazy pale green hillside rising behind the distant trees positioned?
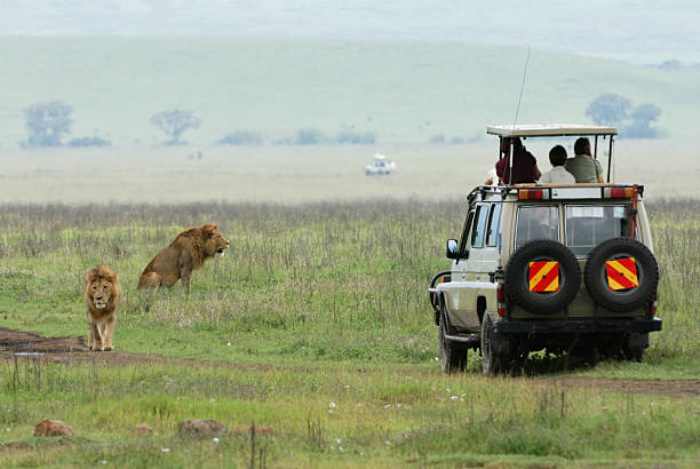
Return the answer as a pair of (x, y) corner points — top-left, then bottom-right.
(0, 36), (700, 148)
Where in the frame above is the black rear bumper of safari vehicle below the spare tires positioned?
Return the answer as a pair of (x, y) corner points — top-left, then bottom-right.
(494, 317), (662, 335)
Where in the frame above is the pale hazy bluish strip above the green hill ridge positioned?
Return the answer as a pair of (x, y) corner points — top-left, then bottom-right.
(0, 0), (700, 63)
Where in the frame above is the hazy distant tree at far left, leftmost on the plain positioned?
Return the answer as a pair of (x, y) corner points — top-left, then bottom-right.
(24, 101), (73, 147)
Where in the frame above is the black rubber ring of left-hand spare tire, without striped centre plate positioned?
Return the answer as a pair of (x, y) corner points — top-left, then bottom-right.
(504, 240), (581, 314)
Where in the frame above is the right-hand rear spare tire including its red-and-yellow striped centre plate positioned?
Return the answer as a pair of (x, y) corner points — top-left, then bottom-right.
(584, 238), (659, 313)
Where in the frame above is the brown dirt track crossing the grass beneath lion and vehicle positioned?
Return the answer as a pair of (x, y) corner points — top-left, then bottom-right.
(0, 327), (700, 397)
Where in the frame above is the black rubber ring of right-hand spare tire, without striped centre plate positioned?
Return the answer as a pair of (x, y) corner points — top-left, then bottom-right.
(584, 238), (659, 313)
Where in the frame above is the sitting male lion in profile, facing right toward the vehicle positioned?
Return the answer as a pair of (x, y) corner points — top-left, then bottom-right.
(138, 223), (231, 291)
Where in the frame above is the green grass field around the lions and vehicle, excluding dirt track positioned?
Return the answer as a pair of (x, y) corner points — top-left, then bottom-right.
(0, 199), (700, 467)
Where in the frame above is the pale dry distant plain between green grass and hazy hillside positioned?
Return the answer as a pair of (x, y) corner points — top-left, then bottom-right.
(0, 137), (700, 204)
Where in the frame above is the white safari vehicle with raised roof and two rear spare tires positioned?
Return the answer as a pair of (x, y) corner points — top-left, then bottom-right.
(429, 125), (662, 374)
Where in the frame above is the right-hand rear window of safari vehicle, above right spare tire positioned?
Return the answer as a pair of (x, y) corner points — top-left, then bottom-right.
(566, 205), (627, 256)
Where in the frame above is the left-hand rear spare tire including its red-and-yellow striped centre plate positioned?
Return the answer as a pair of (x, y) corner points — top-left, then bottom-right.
(504, 240), (581, 314)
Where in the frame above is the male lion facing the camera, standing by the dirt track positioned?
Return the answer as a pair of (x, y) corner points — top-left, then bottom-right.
(85, 265), (121, 352)
